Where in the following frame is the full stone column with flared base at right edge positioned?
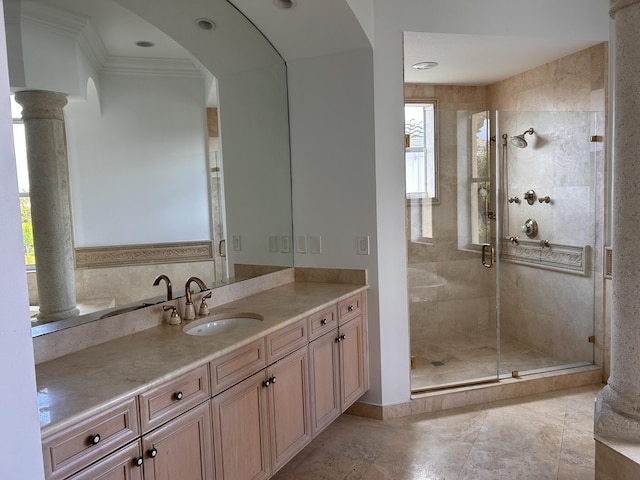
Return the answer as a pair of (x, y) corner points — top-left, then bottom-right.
(595, 0), (640, 443)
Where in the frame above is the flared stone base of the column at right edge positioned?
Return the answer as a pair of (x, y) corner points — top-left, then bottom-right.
(594, 385), (640, 444)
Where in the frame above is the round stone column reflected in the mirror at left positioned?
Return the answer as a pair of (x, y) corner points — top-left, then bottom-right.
(16, 91), (79, 322)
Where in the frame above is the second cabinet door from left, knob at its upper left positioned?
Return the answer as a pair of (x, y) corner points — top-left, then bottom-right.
(142, 402), (213, 480)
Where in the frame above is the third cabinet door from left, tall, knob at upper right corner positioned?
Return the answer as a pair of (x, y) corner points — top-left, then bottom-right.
(211, 370), (270, 480)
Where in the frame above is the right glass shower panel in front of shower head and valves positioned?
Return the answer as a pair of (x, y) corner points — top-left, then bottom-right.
(496, 111), (604, 378)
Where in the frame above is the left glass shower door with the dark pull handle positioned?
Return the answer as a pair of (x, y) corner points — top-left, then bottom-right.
(405, 109), (498, 392)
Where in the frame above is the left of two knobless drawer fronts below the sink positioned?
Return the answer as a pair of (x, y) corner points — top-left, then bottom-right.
(209, 338), (267, 394)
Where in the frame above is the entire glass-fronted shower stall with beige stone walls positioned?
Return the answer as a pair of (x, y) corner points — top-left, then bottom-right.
(405, 106), (605, 392)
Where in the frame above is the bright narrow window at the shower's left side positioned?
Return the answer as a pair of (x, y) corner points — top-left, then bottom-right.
(404, 100), (438, 242)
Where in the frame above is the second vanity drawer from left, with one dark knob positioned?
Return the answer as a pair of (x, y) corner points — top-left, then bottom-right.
(139, 365), (211, 433)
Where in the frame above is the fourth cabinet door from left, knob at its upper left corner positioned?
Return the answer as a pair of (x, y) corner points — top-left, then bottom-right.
(267, 345), (311, 473)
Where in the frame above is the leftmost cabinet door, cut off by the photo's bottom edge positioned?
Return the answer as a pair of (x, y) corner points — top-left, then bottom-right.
(69, 440), (142, 480)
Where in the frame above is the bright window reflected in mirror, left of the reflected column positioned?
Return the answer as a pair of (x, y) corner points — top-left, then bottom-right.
(11, 95), (36, 269)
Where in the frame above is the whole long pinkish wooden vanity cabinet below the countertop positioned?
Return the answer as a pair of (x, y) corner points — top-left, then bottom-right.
(42, 293), (368, 480)
